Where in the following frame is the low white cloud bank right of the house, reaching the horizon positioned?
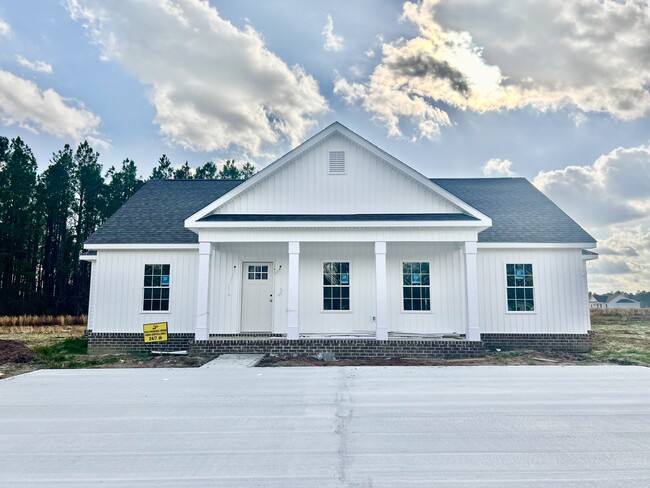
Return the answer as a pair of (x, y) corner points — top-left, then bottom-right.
(534, 146), (650, 292)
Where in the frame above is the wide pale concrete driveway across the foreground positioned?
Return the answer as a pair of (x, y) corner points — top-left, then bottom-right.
(0, 366), (650, 488)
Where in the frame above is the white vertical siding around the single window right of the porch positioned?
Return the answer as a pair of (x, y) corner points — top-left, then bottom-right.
(478, 248), (590, 334)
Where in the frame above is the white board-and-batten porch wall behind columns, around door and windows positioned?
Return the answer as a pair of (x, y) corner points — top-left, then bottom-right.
(209, 242), (466, 334)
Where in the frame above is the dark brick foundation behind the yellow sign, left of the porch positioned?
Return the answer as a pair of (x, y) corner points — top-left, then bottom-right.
(87, 332), (194, 354)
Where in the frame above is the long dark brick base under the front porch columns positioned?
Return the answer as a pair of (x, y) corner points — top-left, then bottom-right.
(190, 339), (485, 359)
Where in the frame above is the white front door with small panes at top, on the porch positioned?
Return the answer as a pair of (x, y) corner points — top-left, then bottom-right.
(241, 263), (273, 332)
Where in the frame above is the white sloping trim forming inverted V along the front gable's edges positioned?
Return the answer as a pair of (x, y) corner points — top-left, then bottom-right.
(185, 122), (492, 228)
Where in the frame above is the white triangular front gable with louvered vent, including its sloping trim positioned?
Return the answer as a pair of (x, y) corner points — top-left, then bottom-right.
(186, 123), (490, 227)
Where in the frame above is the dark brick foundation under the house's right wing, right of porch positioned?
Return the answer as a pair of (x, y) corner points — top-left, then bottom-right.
(481, 333), (591, 352)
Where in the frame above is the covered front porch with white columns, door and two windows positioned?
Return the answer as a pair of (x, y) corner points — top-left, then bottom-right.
(190, 240), (480, 347)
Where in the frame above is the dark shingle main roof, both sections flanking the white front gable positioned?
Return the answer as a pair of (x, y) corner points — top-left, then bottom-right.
(86, 178), (595, 245)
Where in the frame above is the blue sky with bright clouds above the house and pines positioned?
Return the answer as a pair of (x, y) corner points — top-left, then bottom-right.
(0, 0), (650, 293)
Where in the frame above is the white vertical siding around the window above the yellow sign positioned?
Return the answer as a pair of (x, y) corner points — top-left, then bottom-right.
(92, 249), (198, 333)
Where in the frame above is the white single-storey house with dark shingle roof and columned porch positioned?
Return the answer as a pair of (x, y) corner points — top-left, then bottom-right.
(83, 123), (596, 349)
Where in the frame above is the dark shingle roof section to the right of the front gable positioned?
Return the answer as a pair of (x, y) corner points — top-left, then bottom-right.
(432, 178), (596, 247)
